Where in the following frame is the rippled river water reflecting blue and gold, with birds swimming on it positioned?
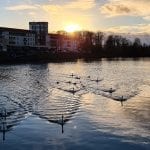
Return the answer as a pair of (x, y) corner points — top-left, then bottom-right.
(0, 60), (150, 150)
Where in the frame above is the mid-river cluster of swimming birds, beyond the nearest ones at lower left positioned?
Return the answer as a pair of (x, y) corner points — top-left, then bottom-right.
(51, 73), (138, 106)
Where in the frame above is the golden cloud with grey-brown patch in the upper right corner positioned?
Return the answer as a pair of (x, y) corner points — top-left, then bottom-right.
(100, 0), (150, 18)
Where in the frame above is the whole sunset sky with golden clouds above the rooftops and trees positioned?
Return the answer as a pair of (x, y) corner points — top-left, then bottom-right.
(0, 0), (150, 33)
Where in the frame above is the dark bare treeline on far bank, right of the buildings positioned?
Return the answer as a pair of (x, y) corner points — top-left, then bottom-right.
(81, 32), (150, 57)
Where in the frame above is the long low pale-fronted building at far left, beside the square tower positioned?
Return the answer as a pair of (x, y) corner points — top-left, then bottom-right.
(0, 27), (36, 51)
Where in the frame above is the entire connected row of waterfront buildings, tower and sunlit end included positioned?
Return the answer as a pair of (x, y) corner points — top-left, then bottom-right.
(0, 22), (81, 53)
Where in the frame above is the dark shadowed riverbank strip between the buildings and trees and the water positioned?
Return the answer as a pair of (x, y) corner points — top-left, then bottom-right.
(0, 51), (150, 64)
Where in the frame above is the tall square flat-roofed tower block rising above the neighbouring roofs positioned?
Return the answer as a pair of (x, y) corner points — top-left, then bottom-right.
(29, 22), (48, 47)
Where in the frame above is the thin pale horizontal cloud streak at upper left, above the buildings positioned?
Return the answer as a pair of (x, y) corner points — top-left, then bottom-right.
(5, 5), (38, 11)
